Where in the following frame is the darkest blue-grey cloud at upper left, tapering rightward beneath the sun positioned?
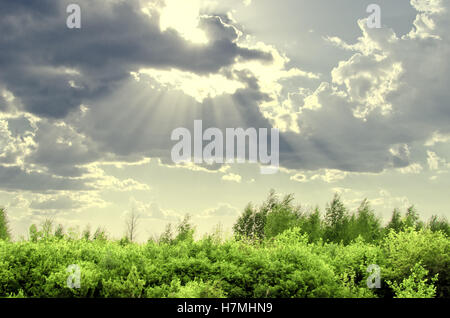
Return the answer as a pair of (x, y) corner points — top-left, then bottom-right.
(0, 0), (271, 118)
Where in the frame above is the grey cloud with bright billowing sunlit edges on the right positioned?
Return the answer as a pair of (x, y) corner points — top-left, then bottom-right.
(280, 1), (450, 172)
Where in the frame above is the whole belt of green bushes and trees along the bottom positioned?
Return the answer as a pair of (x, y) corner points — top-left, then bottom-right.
(0, 191), (450, 298)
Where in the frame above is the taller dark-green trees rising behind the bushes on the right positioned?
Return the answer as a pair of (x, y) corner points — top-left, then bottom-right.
(233, 191), (450, 244)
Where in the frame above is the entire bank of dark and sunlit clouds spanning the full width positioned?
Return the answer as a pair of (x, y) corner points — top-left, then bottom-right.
(0, 0), (450, 200)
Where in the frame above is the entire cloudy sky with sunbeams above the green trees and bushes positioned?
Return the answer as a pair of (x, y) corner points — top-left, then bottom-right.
(0, 0), (450, 241)
